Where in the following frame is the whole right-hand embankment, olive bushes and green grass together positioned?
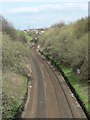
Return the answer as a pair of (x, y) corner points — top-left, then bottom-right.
(39, 18), (90, 112)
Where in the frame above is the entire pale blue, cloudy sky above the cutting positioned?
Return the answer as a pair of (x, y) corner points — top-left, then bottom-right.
(0, 0), (88, 29)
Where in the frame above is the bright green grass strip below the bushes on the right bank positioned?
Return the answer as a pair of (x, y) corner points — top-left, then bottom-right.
(59, 64), (90, 112)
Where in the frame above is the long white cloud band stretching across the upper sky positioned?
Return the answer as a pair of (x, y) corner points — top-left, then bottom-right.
(3, 3), (88, 14)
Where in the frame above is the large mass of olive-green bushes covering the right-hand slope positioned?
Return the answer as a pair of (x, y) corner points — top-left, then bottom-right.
(39, 18), (88, 80)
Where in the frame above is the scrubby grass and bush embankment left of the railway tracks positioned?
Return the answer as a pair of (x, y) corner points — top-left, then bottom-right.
(0, 16), (30, 119)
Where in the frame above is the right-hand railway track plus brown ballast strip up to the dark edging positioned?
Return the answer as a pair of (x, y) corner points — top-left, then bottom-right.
(35, 47), (86, 118)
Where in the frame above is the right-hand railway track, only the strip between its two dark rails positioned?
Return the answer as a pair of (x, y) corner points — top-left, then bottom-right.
(36, 49), (74, 118)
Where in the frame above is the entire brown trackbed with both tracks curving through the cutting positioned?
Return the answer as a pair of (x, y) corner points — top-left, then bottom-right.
(22, 48), (86, 118)
